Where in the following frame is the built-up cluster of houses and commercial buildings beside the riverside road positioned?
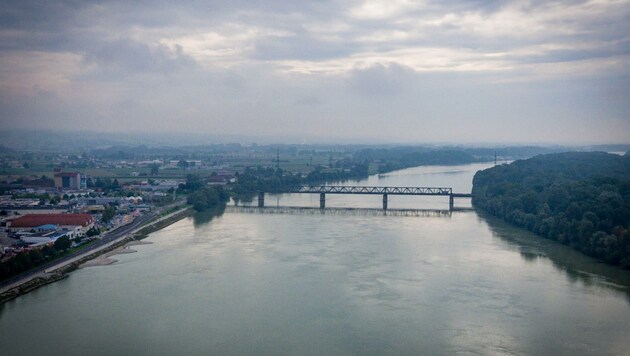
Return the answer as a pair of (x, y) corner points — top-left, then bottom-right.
(0, 170), (179, 269)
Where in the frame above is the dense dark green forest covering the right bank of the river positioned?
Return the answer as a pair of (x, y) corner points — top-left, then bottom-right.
(472, 152), (630, 268)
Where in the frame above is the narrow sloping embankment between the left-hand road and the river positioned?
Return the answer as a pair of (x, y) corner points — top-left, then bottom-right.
(0, 207), (193, 304)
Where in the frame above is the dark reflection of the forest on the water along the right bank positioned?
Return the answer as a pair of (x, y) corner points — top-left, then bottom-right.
(478, 212), (630, 303)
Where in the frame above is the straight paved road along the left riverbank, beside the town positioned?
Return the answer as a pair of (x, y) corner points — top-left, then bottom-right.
(0, 201), (182, 293)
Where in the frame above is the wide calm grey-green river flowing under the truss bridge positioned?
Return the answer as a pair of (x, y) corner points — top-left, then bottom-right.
(0, 164), (630, 355)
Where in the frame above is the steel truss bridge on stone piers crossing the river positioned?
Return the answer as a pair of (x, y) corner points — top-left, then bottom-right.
(258, 185), (472, 210)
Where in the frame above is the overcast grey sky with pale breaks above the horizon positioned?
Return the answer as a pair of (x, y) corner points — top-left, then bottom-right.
(0, 0), (630, 143)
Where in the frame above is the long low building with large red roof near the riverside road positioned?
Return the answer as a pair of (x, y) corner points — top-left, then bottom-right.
(8, 214), (94, 236)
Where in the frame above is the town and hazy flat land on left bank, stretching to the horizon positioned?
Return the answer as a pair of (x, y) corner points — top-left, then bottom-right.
(0, 144), (386, 278)
